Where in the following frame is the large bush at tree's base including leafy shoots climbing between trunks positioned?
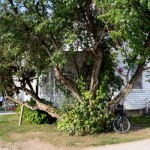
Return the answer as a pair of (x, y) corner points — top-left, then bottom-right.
(57, 69), (118, 135)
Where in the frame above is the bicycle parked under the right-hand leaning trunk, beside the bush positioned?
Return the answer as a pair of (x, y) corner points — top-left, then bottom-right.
(113, 104), (130, 133)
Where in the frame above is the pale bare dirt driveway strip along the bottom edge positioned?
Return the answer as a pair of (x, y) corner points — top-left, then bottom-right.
(0, 139), (150, 150)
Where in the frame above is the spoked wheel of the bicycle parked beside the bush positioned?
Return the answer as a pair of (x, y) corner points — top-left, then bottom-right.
(113, 116), (130, 133)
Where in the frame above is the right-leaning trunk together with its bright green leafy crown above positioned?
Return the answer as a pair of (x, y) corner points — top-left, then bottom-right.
(100, 0), (150, 110)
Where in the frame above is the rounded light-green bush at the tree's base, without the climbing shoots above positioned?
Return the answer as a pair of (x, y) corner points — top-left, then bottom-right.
(57, 100), (112, 135)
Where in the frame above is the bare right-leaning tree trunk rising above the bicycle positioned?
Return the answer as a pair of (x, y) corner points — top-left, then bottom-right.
(110, 63), (145, 112)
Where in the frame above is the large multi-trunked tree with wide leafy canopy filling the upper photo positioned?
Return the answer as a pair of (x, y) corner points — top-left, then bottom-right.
(0, 0), (150, 117)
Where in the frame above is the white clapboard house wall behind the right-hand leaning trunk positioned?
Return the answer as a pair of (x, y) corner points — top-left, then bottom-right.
(113, 50), (150, 110)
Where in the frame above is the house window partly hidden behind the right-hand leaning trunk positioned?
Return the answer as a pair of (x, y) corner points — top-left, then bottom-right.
(131, 66), (143, 89)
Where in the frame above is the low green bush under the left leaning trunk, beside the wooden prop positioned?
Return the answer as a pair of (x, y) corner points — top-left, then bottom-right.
(17, 106), (56, 124)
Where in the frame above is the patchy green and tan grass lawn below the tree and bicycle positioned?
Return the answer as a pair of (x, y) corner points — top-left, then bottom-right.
(0, 115), (150, 147)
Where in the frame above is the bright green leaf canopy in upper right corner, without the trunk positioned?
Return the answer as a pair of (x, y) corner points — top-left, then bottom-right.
(99, 0), (150, 65)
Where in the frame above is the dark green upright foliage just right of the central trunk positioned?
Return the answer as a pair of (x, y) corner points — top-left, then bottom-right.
(96, 47), (124, 99)
